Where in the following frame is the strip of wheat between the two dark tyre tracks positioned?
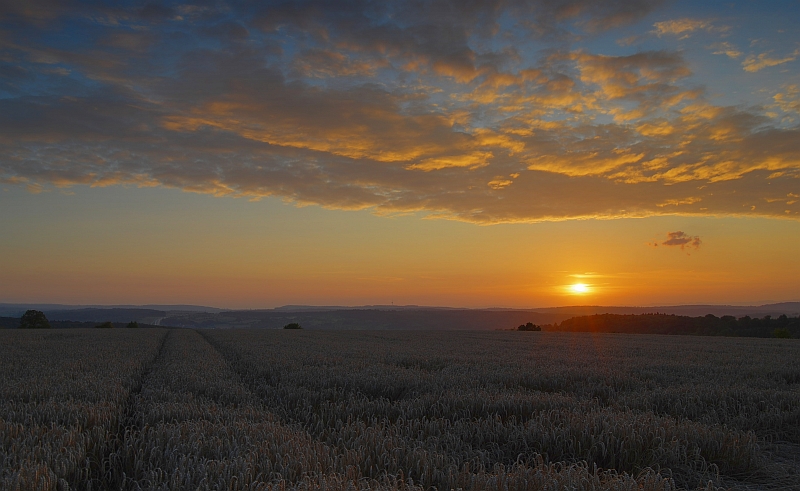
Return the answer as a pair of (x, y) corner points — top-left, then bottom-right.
(115, 329), (356, 490)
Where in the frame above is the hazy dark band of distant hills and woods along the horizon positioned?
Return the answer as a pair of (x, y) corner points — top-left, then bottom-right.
(0, 302), (800, 330)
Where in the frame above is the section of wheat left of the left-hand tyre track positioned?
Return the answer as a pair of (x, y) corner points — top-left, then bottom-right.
(0, 329), (166, 490)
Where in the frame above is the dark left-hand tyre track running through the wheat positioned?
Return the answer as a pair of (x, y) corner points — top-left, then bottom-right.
(83, 329), (172, 489)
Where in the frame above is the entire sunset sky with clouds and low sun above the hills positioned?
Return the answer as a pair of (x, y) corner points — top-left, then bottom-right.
(0, 0), (800, 308)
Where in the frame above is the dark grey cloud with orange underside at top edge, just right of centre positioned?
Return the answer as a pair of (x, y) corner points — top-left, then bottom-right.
(251, 0), (661, 82)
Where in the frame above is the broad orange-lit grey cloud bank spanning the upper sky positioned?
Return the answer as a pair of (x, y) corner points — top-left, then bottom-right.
(0, 0), (800, 224)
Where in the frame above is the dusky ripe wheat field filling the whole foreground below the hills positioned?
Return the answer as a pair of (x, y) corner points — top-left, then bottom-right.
(0, 329), (800, 491)
